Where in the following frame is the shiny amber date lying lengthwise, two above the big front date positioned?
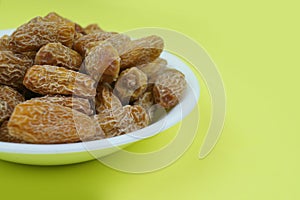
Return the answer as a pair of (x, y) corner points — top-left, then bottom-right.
(23, 65), (96, 98)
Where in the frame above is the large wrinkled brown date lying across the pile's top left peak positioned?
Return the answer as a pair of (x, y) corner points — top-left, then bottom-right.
(9, 17), (75, 52)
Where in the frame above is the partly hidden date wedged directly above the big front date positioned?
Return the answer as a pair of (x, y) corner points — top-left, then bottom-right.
(31, 95), (94, 115)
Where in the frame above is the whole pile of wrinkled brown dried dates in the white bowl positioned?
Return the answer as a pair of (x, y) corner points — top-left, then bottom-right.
(0, 12), (187, 144)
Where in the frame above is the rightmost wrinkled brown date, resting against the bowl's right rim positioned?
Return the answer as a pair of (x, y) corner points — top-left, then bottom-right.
(153, 69), (187, 109)
